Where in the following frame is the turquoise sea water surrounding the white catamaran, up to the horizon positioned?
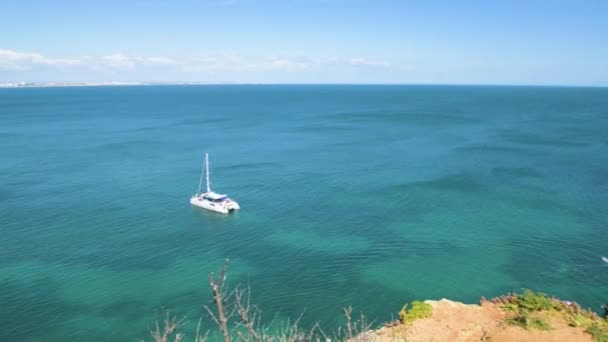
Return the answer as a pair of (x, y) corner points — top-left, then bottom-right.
(0, 86), (608, 341)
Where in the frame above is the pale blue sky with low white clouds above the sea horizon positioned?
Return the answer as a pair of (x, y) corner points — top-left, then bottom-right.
(0, 0), (608, 86)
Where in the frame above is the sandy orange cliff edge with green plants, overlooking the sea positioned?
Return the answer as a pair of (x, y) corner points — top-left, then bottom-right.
(360, 299), (604, 342)
